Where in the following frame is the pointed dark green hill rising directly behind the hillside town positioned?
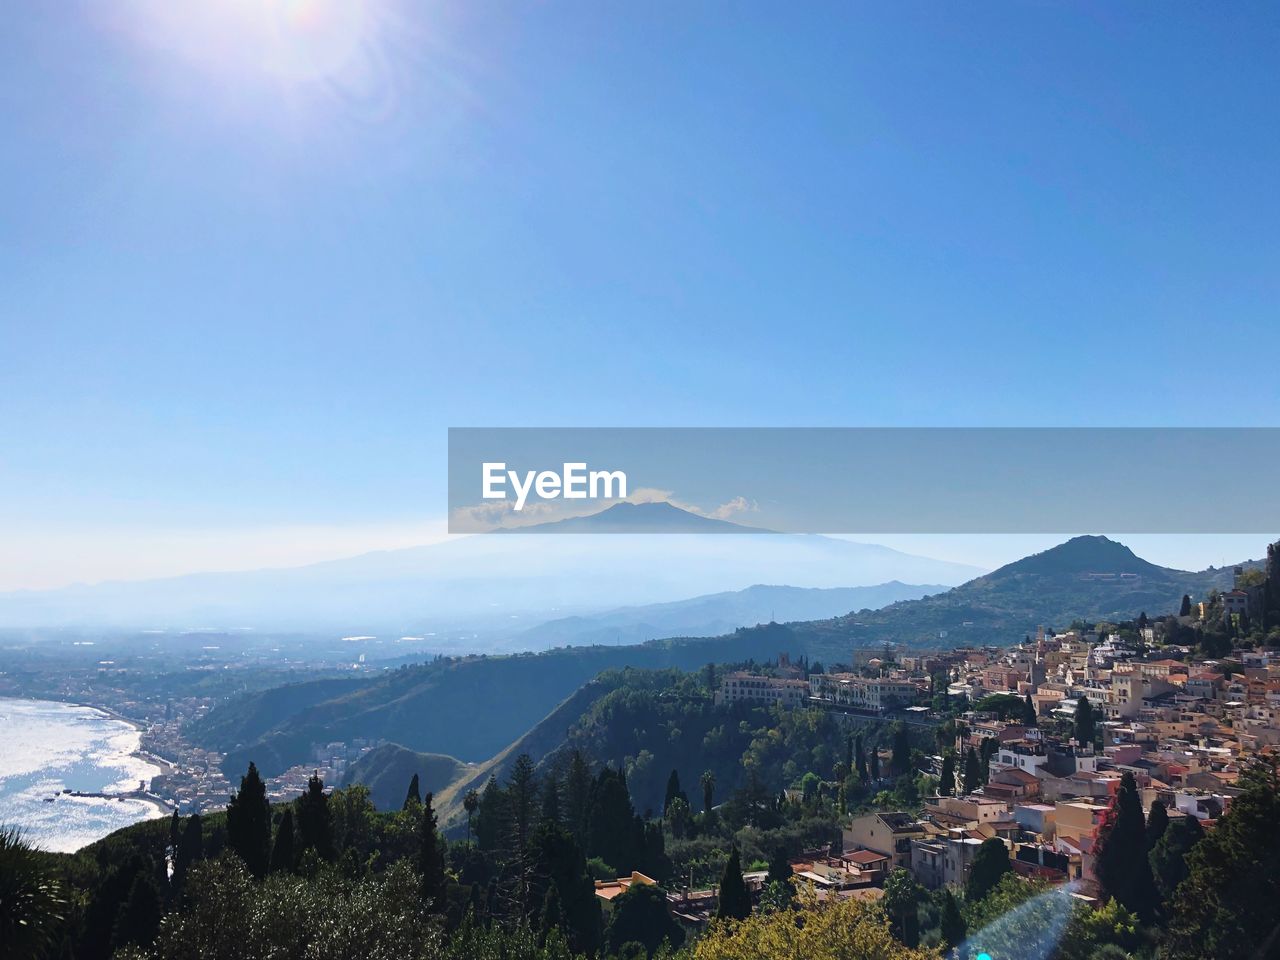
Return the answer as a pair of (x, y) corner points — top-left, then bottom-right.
(778, 536), (1260, 660)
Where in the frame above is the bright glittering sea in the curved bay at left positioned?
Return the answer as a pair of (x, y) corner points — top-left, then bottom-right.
(0, 698), (165, 852)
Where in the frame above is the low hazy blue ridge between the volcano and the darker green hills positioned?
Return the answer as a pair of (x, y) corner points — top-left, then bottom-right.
(512, 580), (947, 650)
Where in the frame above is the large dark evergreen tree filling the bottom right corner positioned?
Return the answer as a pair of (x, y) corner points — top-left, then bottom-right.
(1167, 760), (1280, 960)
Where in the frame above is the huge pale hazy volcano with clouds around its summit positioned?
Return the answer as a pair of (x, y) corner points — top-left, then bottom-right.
(0, 504), (980, 634)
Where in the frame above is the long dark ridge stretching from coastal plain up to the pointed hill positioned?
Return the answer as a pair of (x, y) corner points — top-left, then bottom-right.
(189, 536), (1256, 776)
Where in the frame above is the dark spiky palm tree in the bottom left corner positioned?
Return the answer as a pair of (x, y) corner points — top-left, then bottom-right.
(0, 828), (67, 960)
